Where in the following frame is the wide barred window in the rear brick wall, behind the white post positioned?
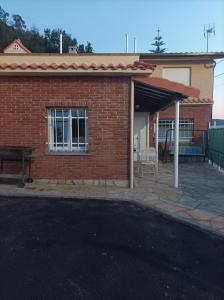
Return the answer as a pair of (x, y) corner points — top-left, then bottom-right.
(159, 119), (194, 142)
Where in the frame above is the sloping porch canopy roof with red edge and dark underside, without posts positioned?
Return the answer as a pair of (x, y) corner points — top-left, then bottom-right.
(132, 76), (200, 114)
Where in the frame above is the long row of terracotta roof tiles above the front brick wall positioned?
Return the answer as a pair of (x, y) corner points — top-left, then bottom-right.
(0, 61), (156, 71)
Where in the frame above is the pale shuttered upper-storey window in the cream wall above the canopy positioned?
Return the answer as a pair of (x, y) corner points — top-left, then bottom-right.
(163, 68), (191, 85)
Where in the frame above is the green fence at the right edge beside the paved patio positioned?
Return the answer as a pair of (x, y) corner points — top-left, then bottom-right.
(208, 127), (224, 169)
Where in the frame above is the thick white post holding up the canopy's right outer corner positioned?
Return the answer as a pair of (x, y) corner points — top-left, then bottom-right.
(174, 101), (180, 188)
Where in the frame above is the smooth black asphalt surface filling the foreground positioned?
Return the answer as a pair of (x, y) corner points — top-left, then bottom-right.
(0, 197), (224, 300)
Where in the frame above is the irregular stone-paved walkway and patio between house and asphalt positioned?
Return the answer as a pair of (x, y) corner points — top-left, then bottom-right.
(0, 163), (224, 236)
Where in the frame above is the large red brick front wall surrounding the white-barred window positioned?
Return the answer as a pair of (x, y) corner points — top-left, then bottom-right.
(0, 77), (129, 180)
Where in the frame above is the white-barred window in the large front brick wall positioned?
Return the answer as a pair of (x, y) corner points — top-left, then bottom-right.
(48, 108), (88, 153)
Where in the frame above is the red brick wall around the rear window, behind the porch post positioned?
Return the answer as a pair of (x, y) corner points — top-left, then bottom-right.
(150, 104), (212, 143)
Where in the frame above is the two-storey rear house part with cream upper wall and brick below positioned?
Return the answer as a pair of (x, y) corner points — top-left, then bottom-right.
(139, 52), (223, 152)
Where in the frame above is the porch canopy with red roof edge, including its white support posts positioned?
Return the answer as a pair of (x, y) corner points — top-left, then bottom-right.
(130, 76), (200, 188)
